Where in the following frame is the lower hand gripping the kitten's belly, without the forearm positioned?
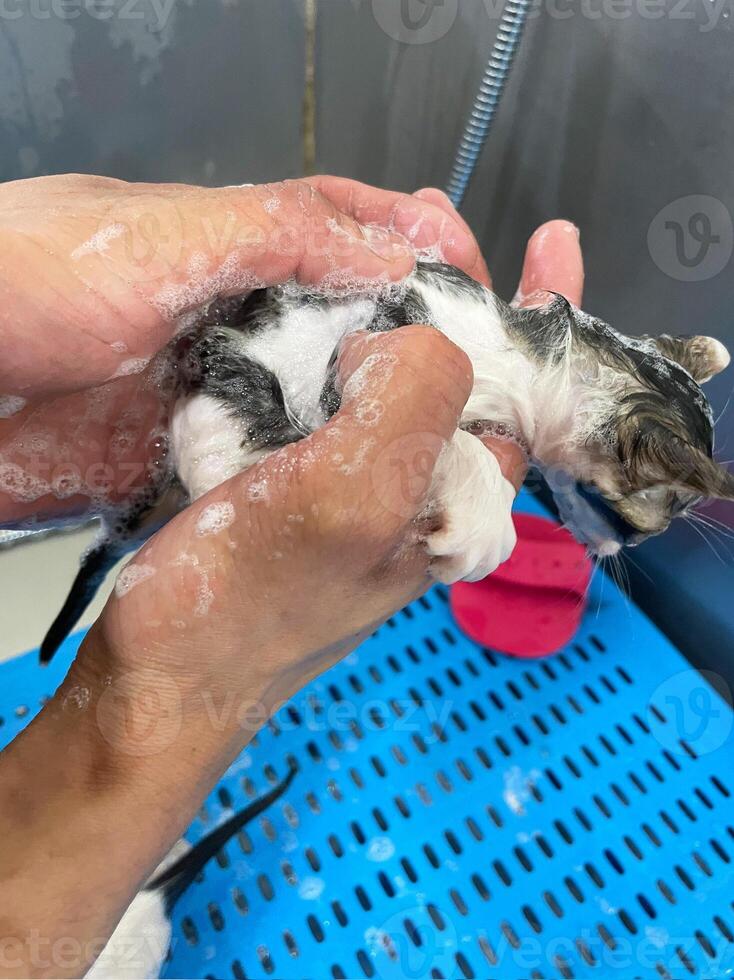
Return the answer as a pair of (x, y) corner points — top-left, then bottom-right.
(87, 216), (583, 751)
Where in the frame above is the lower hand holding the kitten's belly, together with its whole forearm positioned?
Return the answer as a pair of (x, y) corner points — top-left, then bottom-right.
(0, 205), (582, 977)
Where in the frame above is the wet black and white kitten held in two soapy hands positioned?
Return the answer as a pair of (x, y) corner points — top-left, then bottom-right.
(42, 262), (734, 660)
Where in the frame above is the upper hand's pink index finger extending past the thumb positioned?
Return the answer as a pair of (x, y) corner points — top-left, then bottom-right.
(307, 176), (482, 278)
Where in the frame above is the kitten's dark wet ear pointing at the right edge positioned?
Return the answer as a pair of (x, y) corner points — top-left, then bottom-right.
(633, 426), (734, 500)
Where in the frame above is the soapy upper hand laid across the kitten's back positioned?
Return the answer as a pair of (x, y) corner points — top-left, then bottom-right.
(0, 175), (487, 526)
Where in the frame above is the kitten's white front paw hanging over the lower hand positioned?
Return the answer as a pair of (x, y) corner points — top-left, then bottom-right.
(426, 431), (517, 585)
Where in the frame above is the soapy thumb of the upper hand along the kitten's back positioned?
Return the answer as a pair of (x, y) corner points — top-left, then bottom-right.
(121, 180), (415, 310)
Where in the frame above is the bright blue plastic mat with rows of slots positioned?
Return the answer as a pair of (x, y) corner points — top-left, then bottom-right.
(0, 498), (734, 980)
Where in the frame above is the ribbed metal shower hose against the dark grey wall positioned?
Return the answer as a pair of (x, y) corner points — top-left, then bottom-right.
(446, 0), (532, 208)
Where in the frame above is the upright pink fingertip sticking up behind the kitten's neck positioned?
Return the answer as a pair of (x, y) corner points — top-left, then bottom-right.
(513, 220), (584, 307)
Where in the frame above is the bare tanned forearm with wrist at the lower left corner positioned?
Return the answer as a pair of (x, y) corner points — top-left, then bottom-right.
(0, 634), (268, 977)
